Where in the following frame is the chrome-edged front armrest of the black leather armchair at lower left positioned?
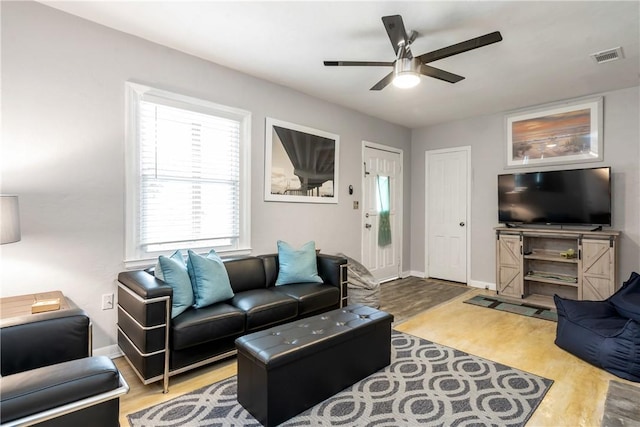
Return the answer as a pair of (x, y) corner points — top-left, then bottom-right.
(0, 356), (129, 425)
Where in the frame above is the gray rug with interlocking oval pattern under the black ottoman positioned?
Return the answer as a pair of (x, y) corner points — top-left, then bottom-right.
(128, 331), (553, 427)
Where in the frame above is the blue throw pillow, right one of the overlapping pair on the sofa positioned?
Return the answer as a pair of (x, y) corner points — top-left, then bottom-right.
(187, 249), (234, 308)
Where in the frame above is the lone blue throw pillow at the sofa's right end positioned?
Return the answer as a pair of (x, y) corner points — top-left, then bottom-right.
(276, 240), (323, 286)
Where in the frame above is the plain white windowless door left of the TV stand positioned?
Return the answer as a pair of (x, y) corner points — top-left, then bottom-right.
(425, 147), (471, 283)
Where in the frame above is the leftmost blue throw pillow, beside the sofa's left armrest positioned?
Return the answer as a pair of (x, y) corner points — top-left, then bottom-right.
(154, 251), (193, 319)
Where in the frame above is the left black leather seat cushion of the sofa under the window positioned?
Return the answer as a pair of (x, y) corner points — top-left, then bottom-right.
(171, 302), (245, 350)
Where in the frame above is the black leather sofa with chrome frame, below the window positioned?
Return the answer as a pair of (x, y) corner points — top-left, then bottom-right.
(118, 254), (347, 393)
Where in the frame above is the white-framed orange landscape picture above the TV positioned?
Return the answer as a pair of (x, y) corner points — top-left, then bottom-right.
(505, 97), (603, 168)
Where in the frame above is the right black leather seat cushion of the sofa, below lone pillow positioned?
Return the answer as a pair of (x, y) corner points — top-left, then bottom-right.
(274, 283), (340, 316)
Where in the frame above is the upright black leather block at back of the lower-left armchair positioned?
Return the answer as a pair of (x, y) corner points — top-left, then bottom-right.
(0, 308), (91, 376)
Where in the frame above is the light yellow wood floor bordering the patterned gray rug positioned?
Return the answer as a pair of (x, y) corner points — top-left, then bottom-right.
(116, 290), (634, 427)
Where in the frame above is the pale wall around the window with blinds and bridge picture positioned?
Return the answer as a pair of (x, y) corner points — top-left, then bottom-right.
(0, 2), (411, 349)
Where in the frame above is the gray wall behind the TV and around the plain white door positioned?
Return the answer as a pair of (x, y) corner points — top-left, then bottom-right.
(411, 87), (640, 285)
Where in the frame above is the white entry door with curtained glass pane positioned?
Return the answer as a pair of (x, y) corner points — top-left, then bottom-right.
(362, 143), (402, 282)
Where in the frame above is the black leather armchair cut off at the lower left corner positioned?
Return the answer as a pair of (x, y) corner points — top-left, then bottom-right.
(0, 307), (129, 427)
